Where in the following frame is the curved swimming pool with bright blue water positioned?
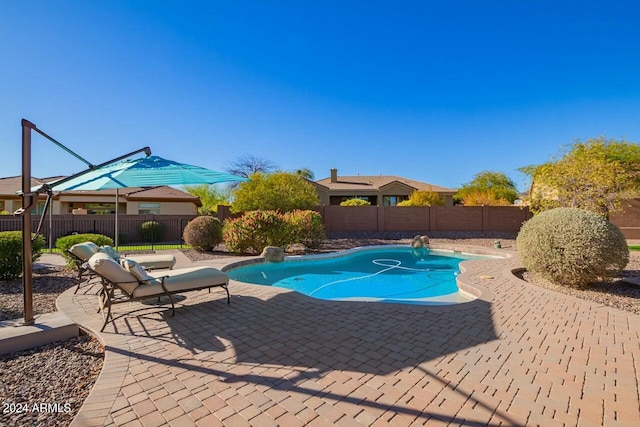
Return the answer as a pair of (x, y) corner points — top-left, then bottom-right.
(226, 246), (482, 304)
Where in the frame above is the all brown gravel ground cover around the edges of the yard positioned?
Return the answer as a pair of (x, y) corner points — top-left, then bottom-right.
(0, 233), (640, 426)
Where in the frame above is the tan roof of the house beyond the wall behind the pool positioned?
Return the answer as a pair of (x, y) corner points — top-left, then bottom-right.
(316, 175), (456, 194)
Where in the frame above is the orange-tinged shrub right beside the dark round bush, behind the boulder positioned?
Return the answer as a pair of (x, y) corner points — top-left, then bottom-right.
(223, 211), (288, 254)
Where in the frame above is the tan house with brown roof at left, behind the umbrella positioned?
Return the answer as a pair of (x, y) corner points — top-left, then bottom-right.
(0, 176), (202, 215)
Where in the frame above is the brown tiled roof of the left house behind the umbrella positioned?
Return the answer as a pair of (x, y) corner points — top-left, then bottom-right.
(0, 176), (201, 206)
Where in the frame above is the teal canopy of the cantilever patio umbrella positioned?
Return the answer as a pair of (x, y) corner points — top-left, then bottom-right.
(49, 156), (247, 191)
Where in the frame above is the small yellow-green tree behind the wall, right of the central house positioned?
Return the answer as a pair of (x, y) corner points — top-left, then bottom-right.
(453, 171), (518, 206)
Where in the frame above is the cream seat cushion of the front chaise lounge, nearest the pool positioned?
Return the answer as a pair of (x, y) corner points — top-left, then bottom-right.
(133, 267), (229, 297)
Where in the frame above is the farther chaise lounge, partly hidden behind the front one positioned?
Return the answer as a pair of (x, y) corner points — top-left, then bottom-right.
(67, 242), (176, 292)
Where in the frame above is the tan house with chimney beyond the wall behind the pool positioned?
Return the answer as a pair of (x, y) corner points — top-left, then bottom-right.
(315, 168), (457, 206)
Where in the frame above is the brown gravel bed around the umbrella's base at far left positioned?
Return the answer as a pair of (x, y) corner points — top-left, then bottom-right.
(0, 268), (104, 426)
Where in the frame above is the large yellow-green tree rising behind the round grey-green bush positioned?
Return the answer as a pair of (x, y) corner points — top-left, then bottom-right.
(520, 137), (640, 218)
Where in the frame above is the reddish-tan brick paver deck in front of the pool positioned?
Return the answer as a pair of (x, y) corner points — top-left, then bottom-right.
(58, 247), (640, 427)
